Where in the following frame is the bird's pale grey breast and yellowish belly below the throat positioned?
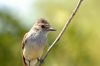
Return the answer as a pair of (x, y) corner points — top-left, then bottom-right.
(23, 32), (47, 59)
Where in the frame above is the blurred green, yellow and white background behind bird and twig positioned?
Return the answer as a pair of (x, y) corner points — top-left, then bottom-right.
(0, 0), (100, 66)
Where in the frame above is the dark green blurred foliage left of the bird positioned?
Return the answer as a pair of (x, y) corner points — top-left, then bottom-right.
(0, 10), (26, 66)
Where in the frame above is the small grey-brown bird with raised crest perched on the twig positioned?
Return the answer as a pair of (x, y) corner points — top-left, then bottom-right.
(22, 18), (56, 66)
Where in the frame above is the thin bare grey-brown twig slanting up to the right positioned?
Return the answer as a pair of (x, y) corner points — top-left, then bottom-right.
(38, 0), (83, 66)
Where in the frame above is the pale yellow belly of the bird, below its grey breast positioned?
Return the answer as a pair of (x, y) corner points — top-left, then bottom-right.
(23, 43), (43, 60)
